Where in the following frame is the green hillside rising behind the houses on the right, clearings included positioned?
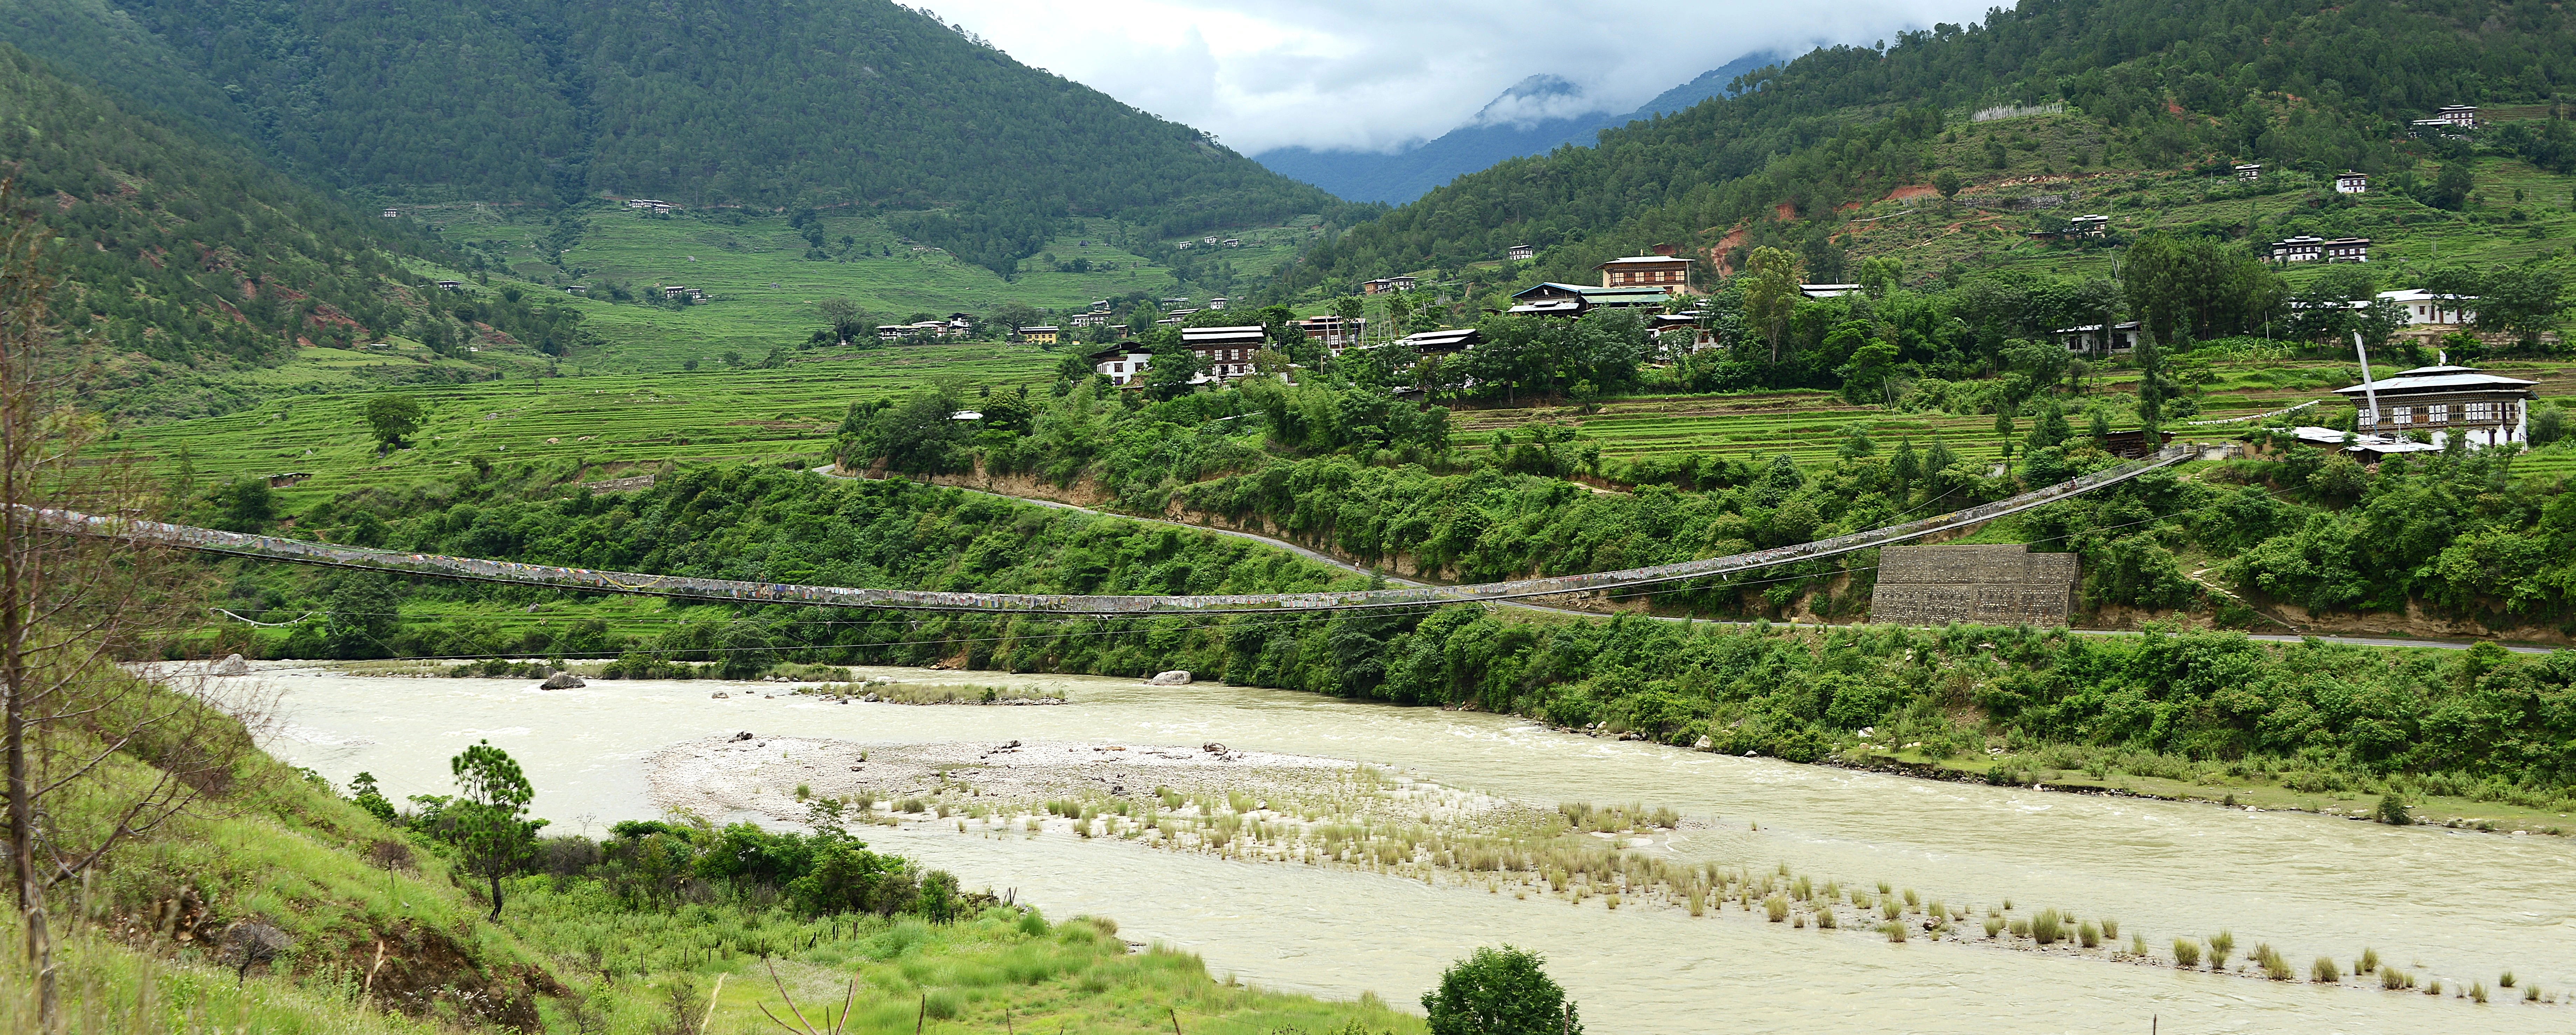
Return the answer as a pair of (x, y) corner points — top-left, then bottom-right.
(1275, 0), (2576, 296)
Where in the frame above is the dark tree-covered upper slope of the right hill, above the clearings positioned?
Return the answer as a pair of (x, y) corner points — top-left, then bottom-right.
(1278, 0), (2576, 293)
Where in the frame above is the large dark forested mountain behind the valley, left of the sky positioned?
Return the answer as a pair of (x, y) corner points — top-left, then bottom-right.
(0, 0), (1332, 270)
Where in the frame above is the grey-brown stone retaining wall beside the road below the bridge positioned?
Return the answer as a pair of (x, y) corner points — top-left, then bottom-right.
(1870, 543), (2079, 626)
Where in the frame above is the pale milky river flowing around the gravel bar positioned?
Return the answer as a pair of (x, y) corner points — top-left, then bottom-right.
(258, 667), (2576, 1035)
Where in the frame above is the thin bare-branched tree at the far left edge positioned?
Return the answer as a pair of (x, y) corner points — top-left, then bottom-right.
(0, 178), (258, 1033)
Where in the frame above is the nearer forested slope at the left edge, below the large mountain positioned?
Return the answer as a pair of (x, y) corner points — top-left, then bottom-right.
(0, 44), (577, 420)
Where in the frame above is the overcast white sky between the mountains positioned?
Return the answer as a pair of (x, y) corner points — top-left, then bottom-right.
(917, 0), (1994, 154)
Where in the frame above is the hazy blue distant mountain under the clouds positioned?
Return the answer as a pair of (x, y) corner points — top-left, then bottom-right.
(1252, 51), (1777, 206)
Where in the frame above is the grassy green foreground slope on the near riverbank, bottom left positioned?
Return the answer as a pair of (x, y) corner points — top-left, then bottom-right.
(0, 680), (1422, 1035)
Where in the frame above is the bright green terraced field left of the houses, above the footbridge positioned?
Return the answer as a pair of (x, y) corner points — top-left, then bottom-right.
(111, 342), (1059, 510)
